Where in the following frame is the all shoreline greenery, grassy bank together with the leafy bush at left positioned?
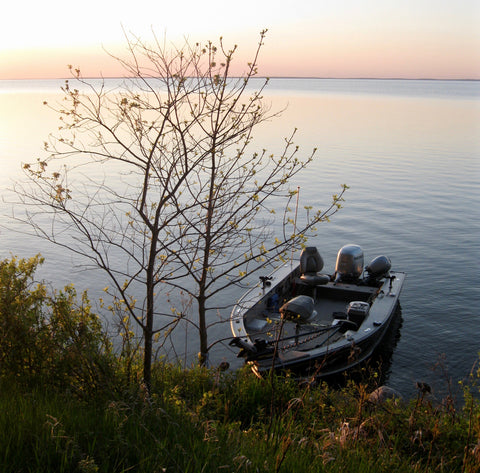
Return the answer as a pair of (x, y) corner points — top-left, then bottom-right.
(0, 257), (480, 473)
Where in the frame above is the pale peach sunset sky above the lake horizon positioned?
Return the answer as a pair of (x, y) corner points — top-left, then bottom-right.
(0, 0), (480, 79)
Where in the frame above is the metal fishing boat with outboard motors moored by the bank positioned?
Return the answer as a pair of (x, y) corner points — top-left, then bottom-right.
(230, 244), (406, 377)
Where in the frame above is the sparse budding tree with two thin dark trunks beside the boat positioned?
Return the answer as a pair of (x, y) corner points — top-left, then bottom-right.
(16, 32), (344, 388)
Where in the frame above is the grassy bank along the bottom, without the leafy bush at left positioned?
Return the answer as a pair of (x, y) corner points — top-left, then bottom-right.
(0, 365), (480, 472)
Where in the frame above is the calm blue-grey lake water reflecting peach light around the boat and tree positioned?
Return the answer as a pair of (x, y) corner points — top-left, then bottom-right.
(0, 79), (480, 395)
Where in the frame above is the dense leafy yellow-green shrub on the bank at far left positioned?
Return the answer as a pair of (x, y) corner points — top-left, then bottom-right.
(0, 255), (114, 395)
